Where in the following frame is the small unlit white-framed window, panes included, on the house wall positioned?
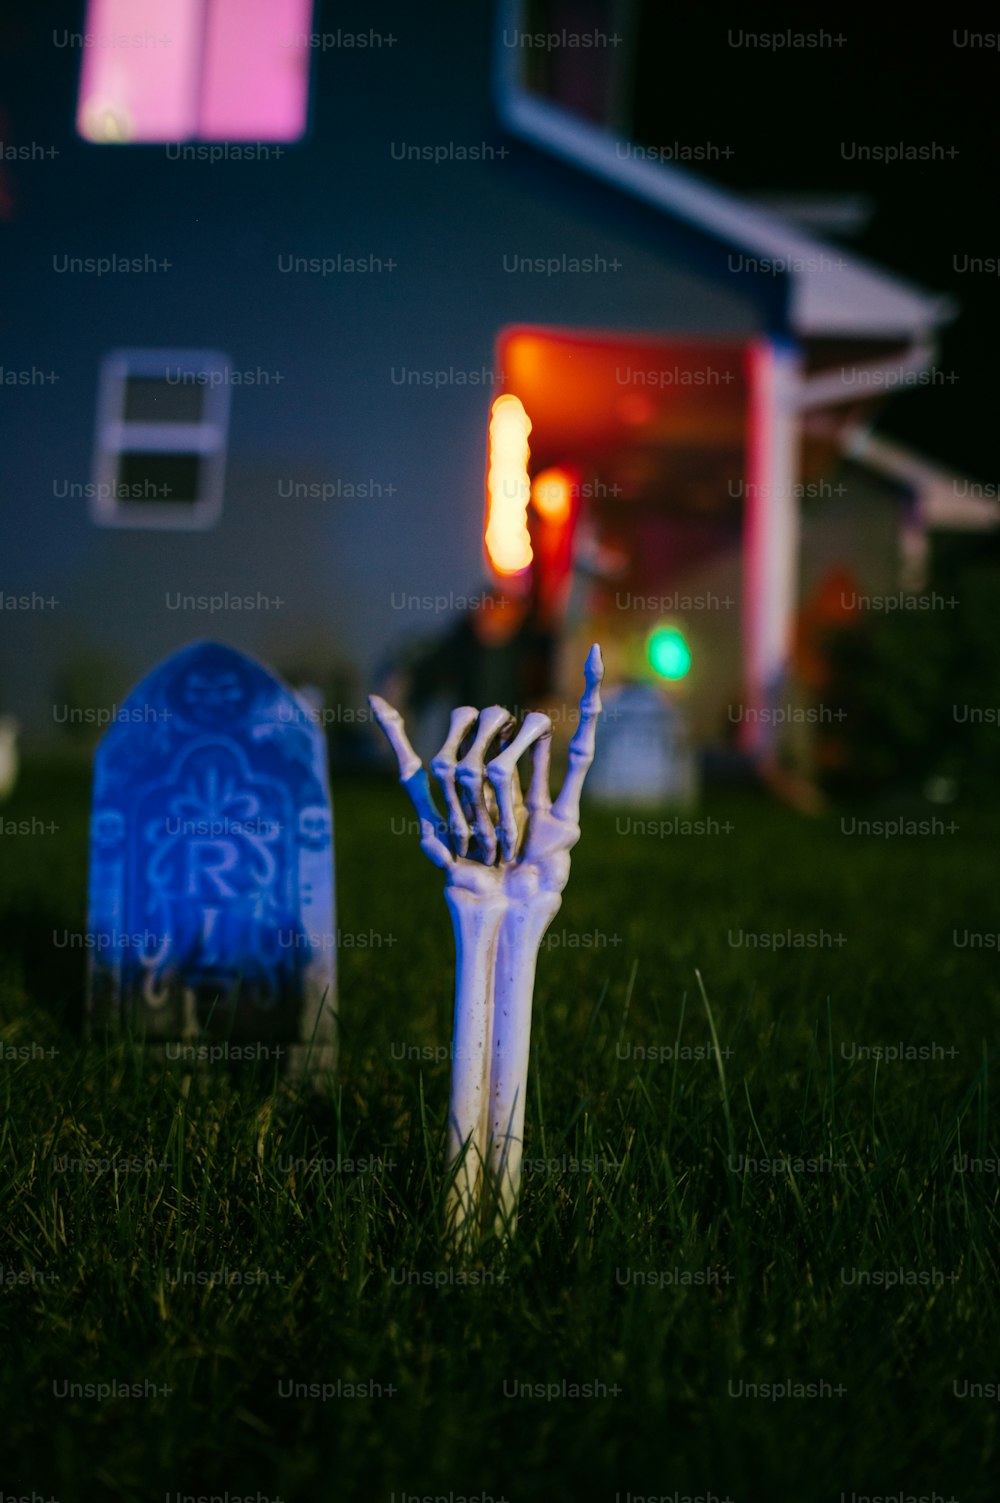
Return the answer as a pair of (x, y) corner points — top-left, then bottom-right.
(90, 350), (230, 529)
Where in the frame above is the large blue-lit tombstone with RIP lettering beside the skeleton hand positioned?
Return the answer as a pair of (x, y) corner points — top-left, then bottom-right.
(87, 642), (337, 1078)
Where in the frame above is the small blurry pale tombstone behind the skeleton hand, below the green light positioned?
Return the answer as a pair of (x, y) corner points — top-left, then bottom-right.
(586, 684), (698, 807)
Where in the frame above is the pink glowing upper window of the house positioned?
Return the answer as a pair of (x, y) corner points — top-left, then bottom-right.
(77, 0), (313, 144)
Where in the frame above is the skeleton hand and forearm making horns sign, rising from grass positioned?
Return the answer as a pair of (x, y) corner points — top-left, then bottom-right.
(370, 645), (605, 1238)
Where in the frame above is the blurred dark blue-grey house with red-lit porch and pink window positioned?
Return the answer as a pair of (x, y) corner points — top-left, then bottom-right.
(0, 0), (995, 748)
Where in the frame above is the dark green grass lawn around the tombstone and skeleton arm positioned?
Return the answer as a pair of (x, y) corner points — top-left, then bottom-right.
(0, 767), (1000, 1503)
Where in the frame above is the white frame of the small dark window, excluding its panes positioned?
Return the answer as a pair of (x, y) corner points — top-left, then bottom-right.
(90, 349), (230, 532)
